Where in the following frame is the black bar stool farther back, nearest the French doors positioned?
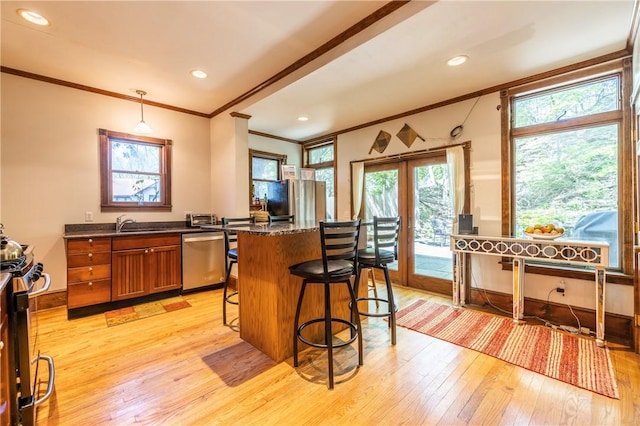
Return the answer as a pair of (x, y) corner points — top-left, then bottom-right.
(355, 217), (400, 345)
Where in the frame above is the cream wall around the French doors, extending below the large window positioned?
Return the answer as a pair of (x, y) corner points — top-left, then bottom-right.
(336, 93), (633, 316)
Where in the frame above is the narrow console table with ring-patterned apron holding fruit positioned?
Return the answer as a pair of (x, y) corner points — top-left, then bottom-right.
(451, 235), (609, 346)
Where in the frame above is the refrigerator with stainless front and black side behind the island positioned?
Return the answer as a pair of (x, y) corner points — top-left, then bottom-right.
(267, 179), (327, 223)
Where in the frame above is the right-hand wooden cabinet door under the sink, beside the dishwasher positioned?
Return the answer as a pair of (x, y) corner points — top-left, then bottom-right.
(148, 246), (182, 293)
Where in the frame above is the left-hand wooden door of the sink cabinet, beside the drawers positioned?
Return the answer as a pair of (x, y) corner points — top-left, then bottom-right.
(111, 249), (149, 300)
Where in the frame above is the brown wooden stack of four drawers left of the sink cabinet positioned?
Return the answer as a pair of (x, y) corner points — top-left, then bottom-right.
(67, 238), (111, 309)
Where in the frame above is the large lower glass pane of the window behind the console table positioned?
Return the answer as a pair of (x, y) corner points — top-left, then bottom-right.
(514, 124), (619, 268)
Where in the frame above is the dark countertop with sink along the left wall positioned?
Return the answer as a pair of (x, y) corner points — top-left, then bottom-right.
(62, 221), (210, 239)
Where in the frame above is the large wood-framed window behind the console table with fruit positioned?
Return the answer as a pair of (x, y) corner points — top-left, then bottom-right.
(505, 60), (632, 273)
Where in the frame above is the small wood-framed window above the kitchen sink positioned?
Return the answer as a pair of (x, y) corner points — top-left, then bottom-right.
(99, 129), (171, 211)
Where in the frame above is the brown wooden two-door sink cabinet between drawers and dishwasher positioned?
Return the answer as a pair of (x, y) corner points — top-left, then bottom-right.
(111, 234), (182, 301)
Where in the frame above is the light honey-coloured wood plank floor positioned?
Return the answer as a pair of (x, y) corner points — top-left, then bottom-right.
(37, 288), (640, 426)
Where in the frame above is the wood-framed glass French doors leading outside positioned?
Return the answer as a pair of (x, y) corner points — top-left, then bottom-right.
(363, 152), (453, 294)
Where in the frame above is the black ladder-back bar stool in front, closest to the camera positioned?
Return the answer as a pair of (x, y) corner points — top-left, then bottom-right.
(289, 219), (363, 389)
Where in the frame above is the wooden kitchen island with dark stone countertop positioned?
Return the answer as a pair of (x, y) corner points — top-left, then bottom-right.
(202, 223), (367, 362)
